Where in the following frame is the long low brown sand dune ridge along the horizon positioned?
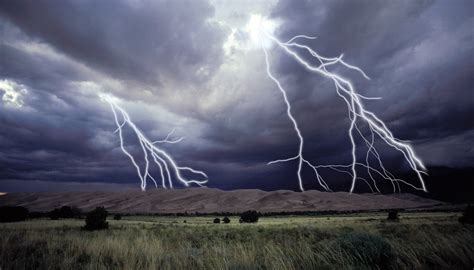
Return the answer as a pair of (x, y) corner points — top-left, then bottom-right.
(0, 188), (441, 213)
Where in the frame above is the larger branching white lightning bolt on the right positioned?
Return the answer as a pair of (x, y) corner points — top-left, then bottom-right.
(258, 23), (427, 193)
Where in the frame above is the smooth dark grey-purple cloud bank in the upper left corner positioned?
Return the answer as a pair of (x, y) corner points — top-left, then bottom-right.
(0, 1), (229, 83)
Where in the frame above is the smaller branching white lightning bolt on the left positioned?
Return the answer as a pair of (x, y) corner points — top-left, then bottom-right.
(100, 94), (208, 191)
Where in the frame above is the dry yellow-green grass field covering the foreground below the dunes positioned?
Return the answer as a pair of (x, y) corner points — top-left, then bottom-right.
(0, 213), (474, 270)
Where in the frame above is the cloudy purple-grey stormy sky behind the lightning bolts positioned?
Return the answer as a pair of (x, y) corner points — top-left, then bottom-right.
(0, 0), (474, 194)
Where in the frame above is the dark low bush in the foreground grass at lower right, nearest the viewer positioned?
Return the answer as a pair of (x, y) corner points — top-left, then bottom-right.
(332, 233), (395, 269)
